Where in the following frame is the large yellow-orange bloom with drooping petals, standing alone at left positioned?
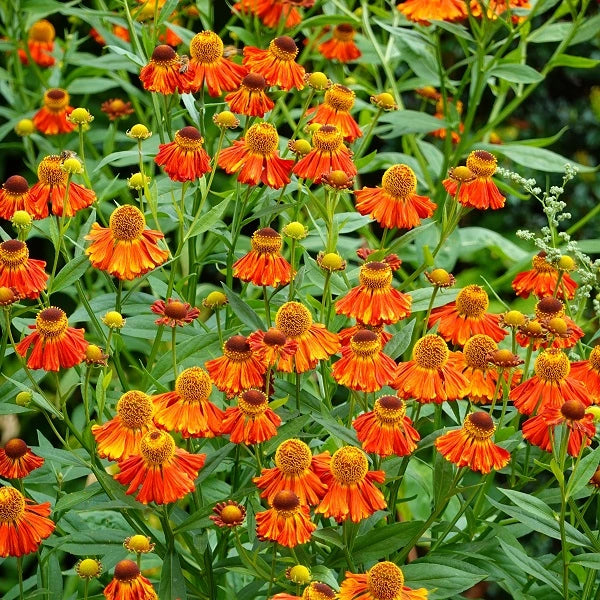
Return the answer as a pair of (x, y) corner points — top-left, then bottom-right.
(85, 204), (169, 279)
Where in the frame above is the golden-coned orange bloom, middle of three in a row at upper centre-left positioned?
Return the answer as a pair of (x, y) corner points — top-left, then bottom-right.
(218, 123), (294, 189)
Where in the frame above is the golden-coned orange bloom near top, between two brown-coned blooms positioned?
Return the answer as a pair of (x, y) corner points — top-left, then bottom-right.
(188, 31), (248, 96)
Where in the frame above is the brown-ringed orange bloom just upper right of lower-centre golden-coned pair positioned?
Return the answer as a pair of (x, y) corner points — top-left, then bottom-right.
(352, 396), (421, 457)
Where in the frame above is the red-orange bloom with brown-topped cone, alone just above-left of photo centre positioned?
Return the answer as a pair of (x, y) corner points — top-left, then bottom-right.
(233, 227), (292, 287)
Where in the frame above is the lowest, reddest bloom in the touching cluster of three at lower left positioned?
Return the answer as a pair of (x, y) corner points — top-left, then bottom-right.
(114, 431), (206, 504)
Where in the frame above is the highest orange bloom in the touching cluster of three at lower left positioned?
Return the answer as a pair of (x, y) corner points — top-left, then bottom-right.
(152, 367), (225, 438)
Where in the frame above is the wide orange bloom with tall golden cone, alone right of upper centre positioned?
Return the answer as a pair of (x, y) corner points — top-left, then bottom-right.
(354, 164), (437, 229)
